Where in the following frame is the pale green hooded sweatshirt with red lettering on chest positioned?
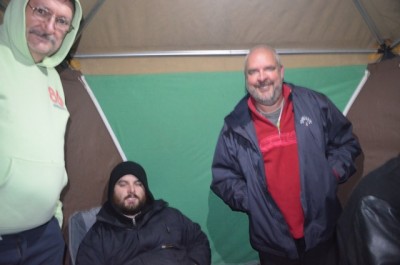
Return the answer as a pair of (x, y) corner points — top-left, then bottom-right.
(0, 0), (82, 235)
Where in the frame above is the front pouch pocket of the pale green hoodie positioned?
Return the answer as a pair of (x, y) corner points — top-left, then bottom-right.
(0, 158), (67, 231)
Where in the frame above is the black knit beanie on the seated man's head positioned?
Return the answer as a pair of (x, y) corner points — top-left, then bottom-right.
(108, 161), (154, 203)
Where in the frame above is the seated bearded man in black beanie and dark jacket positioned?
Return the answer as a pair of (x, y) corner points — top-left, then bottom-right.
(76, 161), (211, 265)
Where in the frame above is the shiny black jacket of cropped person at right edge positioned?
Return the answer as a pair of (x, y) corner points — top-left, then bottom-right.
(337, 154), (400, 265)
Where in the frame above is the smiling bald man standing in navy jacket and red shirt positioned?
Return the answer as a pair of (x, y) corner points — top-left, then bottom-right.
(211, 46), (361, 265)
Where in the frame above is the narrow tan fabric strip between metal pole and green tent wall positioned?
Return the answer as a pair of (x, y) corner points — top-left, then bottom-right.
(73, 54), (370, 75)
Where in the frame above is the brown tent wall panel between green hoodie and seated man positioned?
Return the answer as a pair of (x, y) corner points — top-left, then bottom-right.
(60, 68), (122, 265)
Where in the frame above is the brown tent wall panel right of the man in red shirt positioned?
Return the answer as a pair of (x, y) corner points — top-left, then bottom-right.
(339, 57), (400, 201)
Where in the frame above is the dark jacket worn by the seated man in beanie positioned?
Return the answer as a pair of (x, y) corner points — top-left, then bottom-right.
(76, 200), (211, 265)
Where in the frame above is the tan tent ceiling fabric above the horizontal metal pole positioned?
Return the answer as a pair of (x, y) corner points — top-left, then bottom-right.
(77, 0), (400, 54)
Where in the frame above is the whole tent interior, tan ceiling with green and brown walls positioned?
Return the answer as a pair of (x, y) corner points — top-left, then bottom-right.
(0, 0), (400, 265)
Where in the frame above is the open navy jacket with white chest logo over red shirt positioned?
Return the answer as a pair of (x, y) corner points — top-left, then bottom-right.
(211, 85), (361, 259)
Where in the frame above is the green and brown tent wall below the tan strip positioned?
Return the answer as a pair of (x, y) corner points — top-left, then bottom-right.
(62, 58), (400, 264)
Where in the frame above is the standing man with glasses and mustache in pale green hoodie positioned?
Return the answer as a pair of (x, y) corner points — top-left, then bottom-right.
(0, 0), (82, 265)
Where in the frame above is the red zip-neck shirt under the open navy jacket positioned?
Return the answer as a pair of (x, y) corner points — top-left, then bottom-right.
(248, 85), (304, 239)
